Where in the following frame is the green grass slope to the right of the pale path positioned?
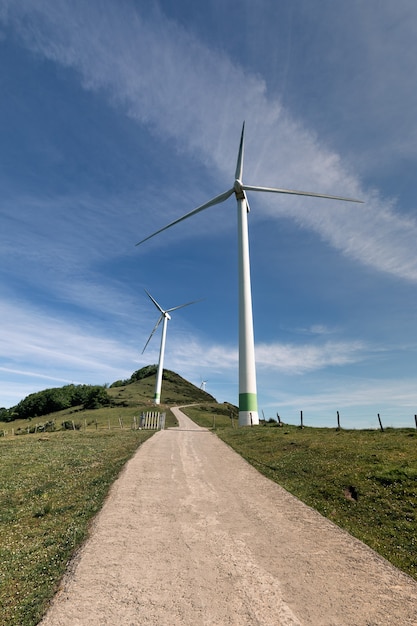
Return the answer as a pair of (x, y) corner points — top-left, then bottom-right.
(184, 406), (417, 579)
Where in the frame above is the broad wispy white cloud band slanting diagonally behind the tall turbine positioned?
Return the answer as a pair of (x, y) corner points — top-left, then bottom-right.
(0, 0), (417, 281)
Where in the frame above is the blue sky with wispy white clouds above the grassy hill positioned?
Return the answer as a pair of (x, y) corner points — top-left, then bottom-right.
(0, 0), (417, 428)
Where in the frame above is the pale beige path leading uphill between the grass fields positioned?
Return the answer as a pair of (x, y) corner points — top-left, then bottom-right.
(41, 410), (417, 626)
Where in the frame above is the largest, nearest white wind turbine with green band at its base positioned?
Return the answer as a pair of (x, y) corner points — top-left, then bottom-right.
(136, 122), (362, 426)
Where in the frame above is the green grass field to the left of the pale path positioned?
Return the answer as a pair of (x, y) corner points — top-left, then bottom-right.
(0, 422), (152, 626)
